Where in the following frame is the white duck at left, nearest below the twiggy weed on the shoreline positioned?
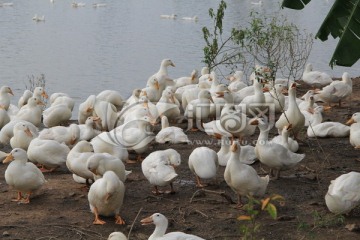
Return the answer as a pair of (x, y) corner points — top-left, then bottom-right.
(15, 97), (44, 127)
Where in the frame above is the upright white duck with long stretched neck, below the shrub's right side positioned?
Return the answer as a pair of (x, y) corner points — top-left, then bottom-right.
(275, 83), (305, 138)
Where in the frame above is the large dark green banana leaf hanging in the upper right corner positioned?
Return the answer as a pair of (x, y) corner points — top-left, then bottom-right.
(315, 0), (360, 67)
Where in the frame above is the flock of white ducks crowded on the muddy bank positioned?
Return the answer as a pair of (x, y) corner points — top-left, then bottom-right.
(0, 59), (360, 239)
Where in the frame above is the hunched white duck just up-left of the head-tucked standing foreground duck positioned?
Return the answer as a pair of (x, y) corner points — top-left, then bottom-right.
(66, 140), (94, 184)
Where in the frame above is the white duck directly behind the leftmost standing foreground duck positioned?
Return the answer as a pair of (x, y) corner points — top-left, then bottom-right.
(10, 122), (37, 151)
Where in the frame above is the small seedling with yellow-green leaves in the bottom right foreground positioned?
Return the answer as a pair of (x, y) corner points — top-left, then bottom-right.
(238, 194), (285, 240)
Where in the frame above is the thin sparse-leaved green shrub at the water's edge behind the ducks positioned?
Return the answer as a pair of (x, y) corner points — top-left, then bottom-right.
(202, 0), (313, 79)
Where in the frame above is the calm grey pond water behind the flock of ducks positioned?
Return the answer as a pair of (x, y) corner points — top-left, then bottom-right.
(0, 0), (360, 116)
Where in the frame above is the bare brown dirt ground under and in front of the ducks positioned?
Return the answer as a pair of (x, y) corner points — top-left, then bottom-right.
(0, 78), (360, 240)
